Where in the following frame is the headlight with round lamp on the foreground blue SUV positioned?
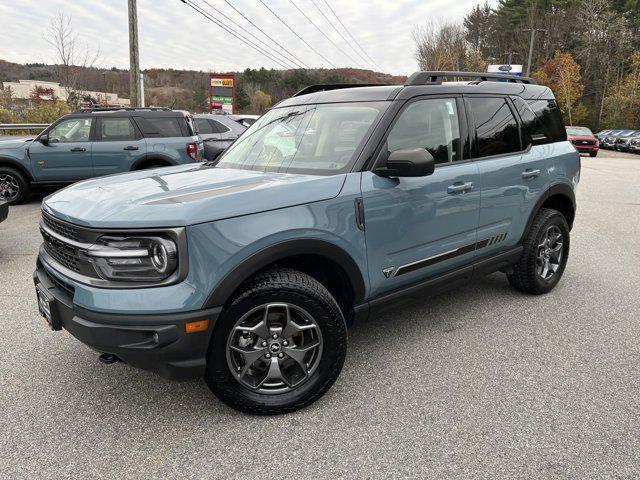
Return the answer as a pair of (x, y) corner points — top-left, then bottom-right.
(84, 236), (178, 282)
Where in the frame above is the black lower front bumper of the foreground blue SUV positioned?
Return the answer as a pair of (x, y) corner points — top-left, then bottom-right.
(33, 265), (221, 380)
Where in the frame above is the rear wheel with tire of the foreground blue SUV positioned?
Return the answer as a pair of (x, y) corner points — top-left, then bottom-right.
(507, 208), (569, 295)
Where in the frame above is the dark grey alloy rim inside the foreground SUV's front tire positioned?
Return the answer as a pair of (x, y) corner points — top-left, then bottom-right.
(226, 303), (322, 394)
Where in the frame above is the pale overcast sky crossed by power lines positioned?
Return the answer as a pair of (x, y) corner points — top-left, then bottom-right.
(0, 0), (478, 74)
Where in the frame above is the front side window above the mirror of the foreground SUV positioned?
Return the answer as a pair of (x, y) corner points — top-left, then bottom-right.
(387, 98), (462, 163)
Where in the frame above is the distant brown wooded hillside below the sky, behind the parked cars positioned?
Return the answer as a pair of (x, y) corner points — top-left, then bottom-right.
(0, 60), (406, 113)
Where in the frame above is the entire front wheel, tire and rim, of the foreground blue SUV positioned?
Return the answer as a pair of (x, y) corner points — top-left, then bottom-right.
(205, 269), (347, 415)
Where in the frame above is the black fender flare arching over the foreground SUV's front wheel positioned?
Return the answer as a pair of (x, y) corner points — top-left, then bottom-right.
(202, 238), (365, 308)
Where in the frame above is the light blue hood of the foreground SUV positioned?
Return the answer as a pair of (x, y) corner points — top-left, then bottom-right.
(42, 164), (346, 228)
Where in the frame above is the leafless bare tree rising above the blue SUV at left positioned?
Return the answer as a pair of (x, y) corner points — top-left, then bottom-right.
(44, 12), (100, 106)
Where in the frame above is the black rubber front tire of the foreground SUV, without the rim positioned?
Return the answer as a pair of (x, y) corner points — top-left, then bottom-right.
(205, 268), (347, 415)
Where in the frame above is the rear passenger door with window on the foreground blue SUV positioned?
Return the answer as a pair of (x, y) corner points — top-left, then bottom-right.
(465, 95), (549, 258)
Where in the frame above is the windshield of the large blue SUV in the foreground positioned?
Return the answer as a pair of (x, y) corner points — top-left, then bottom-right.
(216, 102), (388, 175)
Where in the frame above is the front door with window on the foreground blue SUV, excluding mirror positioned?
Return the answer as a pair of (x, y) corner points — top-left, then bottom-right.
(361, 97), (480, 296)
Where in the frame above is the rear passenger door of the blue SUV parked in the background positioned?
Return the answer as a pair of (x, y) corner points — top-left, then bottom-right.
(93, 114), (147, 177)
